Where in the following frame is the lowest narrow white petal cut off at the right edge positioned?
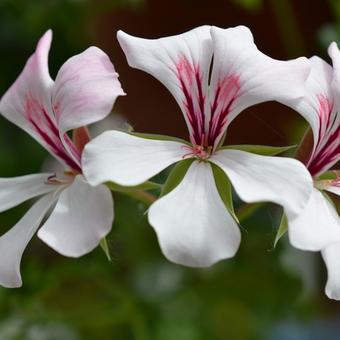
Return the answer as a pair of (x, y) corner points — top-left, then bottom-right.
(321, 243), (340, 300)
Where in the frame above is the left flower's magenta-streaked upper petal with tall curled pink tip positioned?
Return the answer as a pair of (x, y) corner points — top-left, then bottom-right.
(0, 30), (80, 171)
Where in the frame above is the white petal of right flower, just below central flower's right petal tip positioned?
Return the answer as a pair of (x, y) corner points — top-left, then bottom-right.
(288, 189), (340, 251)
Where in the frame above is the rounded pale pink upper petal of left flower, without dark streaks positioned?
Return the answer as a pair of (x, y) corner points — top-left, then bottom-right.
(52, 47), (124, 135)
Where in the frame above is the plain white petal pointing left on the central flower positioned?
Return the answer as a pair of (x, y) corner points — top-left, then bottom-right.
(82, 131), (189, 186)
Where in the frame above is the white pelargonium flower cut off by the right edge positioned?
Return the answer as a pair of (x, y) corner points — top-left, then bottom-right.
(282, 43), (340, 299)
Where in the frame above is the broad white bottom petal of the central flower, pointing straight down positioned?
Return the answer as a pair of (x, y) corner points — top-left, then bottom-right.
(149, 161), (241, 267)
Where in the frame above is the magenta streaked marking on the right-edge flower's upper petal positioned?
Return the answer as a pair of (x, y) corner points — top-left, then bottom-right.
(307, 95), (340, 176)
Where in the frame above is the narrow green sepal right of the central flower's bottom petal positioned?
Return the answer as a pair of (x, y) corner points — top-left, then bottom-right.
(210, 163), (239, 223)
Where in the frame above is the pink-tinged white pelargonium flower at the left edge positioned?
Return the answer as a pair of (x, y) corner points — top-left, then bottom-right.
(0, 30), (123, 287)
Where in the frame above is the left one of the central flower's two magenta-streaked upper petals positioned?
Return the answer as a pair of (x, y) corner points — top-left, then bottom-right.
(117, 26), (212, 145)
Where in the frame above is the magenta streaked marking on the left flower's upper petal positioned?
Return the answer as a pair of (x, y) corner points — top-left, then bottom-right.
(24, 95), (81, 172)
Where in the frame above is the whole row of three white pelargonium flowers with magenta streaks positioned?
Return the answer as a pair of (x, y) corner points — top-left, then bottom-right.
(0, 26), (340, 299)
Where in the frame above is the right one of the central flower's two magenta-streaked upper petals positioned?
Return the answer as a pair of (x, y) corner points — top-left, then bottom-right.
(209, 26), (310, 145)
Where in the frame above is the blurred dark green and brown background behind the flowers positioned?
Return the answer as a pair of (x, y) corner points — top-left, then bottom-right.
(0, 0), (340, 340)
